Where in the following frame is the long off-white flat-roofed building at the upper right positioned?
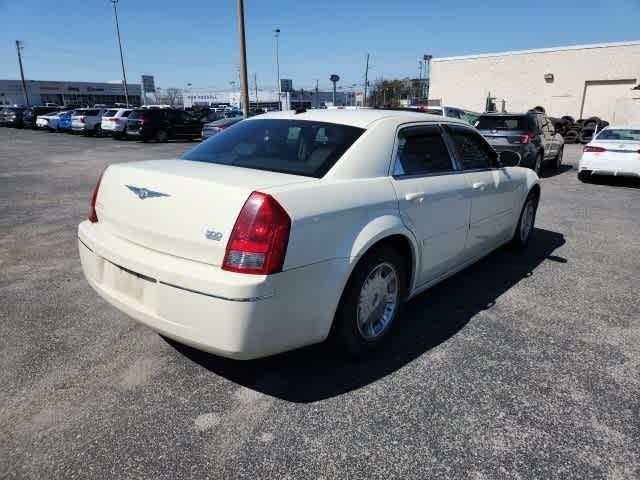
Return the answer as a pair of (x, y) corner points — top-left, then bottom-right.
(429, 41), (640, 123)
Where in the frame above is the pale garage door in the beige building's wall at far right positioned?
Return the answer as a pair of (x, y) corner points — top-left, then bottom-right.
(580, 79), (637, 122)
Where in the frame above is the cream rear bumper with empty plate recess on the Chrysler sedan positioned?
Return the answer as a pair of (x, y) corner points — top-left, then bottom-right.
(78, 221), (348, 360)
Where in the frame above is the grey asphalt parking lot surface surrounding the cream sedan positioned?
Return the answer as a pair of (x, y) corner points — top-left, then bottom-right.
(0, 128), (640, 480)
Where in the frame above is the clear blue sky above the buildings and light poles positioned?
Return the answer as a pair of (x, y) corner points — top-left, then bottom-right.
(0, 0), (640, 93)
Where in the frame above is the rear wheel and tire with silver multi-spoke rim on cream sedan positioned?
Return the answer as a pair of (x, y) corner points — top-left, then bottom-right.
(332, 245), (407, 358)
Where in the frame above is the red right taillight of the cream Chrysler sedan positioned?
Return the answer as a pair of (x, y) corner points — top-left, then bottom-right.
(222, 192), (291, 275)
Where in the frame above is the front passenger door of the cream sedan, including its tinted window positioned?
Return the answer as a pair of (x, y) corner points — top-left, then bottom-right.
(446, 125), (520, 258)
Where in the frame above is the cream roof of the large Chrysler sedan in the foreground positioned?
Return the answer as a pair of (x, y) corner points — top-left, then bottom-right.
(242, 108), (468, 128)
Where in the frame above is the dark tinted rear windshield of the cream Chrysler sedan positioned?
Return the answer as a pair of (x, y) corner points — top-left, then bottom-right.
(182, 119), (364, 178)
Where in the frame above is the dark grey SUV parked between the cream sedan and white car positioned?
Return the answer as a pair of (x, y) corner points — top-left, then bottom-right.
(475, 112), (564, 173)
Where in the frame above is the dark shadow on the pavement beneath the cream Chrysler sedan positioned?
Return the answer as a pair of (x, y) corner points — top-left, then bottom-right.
(166, 229), (567, 403)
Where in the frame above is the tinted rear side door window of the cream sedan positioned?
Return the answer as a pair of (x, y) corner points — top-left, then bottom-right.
(393, 127), (453, 175)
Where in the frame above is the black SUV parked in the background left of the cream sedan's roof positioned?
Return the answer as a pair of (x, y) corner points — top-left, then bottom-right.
(127, 108), (202, 142)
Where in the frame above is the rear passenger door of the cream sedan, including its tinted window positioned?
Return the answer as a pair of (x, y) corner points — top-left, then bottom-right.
(392, 124), (471, 285)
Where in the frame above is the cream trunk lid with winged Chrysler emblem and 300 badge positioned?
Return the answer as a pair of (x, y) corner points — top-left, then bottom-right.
(96, 160), (315, 266)
